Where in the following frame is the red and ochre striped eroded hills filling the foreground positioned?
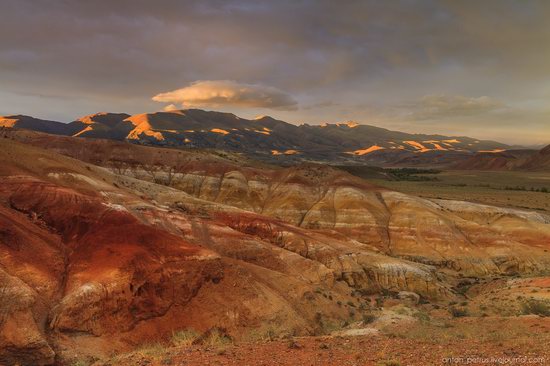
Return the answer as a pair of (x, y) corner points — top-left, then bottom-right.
(0, 134), (550, 365)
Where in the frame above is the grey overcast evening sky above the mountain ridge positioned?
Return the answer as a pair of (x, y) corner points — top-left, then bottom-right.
(0, 0), (550, 145)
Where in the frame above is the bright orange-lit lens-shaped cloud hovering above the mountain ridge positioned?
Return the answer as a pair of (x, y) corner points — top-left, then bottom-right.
(153, 80), (297, 110)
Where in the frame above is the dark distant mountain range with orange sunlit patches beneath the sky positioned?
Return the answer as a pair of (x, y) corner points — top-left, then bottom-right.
(0, 109), (510, 165)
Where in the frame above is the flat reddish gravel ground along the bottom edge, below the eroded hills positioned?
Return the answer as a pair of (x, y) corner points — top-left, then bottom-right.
(94, 317), (550, 366)
